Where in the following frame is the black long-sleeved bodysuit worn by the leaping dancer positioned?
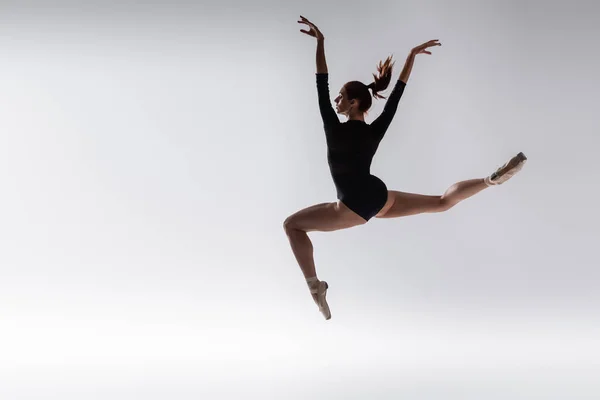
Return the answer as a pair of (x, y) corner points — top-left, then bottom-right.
(317, 73), (406, 221)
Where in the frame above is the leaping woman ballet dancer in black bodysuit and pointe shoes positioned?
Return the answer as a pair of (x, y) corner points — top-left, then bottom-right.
(284, 16), (527, 319)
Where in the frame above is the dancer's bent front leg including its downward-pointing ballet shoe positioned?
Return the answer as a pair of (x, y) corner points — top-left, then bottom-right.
(283, 202), (367, 319)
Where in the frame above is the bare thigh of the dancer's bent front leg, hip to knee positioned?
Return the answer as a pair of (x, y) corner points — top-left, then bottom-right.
(284, 201), (367, 232)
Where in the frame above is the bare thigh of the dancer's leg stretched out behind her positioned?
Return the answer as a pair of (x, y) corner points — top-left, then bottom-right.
(376, 190), (446, 218)
